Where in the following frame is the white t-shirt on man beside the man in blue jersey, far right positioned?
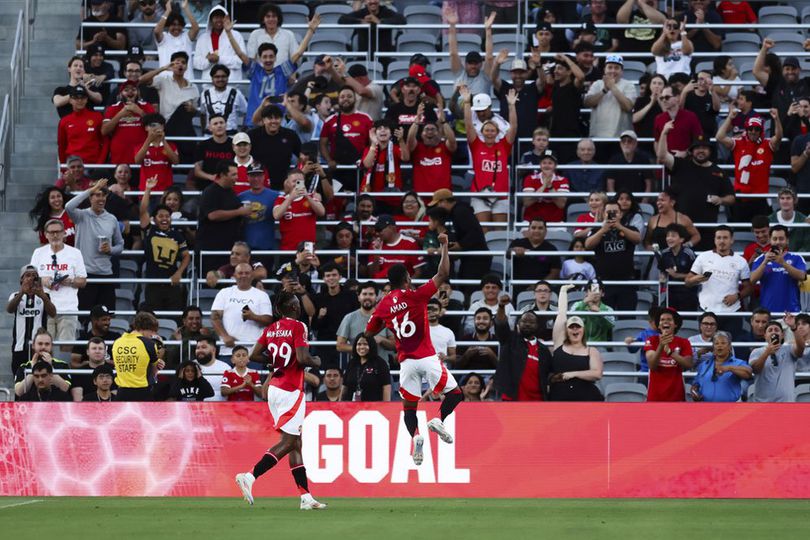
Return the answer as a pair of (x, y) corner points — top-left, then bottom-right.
(691, 251), (751, 313)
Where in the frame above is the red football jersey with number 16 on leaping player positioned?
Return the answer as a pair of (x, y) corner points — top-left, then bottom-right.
(366, 279), (438, 363)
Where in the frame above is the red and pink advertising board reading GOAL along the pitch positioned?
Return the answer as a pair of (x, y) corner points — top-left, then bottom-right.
(0, 403), (810, 501)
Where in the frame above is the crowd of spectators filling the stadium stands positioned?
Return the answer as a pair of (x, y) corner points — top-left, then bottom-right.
(7, 0), (810, 401)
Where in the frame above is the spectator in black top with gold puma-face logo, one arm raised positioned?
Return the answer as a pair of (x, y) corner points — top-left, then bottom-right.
(140, 176), (191, 311)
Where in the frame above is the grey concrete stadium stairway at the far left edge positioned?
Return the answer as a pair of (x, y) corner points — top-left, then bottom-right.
(0, 0), (80, 392)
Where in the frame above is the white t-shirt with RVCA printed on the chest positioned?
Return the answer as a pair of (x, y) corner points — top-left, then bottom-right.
(211, 285), (273, 356)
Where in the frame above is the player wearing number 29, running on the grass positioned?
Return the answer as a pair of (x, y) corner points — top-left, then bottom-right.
(236, 291), (326, 510)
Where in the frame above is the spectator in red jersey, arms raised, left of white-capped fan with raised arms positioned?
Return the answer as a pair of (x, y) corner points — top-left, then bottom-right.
(407, 103), (457, 193)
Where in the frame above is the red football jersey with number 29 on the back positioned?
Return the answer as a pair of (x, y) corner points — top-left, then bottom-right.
(258, 317), (309, 392)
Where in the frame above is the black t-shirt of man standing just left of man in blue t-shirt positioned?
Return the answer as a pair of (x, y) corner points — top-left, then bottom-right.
(197, 183), (242, 250)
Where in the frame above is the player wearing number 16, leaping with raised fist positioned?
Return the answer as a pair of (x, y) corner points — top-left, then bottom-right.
(365, 234), (463, 465)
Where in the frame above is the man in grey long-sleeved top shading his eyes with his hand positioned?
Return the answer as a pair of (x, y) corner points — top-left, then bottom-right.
(64, 178), (124, 311)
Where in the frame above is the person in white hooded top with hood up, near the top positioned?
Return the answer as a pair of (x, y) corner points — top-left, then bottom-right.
(193, 5), (245, 79)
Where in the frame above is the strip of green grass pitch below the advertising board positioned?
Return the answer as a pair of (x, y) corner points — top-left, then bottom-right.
(0, 497), (810, 540)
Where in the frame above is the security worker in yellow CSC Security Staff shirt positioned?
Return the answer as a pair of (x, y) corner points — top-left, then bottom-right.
(112, 312), (165, 401)
